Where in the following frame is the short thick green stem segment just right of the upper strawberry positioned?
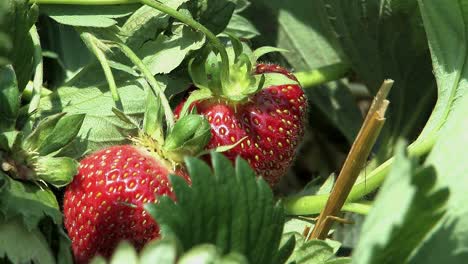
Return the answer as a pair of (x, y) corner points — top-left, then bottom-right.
(294, 63), (349, 88)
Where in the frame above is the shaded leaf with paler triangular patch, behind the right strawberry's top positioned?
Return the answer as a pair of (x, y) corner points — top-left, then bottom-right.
(246, 0), (344, 71)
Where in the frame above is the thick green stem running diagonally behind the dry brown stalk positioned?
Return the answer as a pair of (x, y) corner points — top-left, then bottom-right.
(283, 134), (437, 215)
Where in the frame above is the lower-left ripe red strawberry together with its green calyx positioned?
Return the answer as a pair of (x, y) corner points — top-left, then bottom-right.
(63, 88), (211, 263)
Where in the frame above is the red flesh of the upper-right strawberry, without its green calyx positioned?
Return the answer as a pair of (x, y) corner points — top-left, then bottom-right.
(175, 64), (307, 185)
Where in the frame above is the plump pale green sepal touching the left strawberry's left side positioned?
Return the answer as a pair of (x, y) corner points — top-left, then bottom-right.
(36, 156), (78, 188)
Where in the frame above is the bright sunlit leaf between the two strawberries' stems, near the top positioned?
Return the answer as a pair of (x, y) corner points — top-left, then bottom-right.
(136, 25), (205, 74)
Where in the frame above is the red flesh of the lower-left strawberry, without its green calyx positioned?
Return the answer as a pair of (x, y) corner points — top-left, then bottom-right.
(64, 145), (187, 263)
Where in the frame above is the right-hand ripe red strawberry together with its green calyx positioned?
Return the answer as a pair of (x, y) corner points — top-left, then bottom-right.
(175, 43), (307, 185)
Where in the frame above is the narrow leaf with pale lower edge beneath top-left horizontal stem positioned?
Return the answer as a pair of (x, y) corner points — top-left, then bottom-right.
(41, 5), (138, 28)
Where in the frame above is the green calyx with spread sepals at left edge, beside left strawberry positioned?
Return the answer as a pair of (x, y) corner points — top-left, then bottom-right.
(0, 113), (84, 187)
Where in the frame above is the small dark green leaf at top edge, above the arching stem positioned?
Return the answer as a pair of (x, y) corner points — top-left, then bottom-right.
(187, 0), (236, 34)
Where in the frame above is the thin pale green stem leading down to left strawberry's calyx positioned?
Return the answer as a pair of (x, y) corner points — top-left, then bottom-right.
(116, 42), (175, 131)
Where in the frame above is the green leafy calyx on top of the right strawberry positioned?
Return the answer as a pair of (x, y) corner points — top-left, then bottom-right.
(189, 37), (298, 104)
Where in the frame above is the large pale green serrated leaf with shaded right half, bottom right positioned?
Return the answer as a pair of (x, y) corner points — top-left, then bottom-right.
(353, 144), (449, 263)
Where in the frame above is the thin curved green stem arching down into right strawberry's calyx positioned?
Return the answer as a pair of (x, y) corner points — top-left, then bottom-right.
(140, 0), (229, 80)
